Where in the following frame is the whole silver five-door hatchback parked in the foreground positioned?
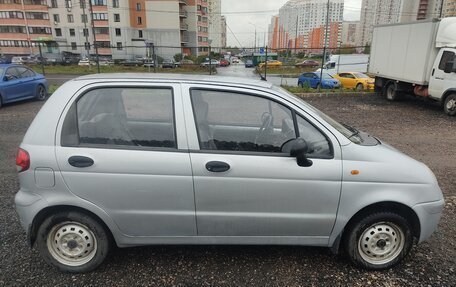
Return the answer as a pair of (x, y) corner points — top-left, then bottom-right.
(15, 74), (444, 272)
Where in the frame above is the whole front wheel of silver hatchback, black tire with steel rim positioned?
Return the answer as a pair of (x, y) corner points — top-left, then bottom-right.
(343, 211), (413, 270)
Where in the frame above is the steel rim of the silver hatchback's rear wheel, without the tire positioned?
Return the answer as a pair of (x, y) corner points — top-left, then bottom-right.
(46, 221), (98, 267)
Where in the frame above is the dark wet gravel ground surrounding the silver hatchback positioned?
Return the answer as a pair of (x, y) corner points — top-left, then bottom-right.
(0, 95), (456, 286)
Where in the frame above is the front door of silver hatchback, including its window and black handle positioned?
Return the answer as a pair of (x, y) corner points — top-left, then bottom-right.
(184, 87), (342, 241)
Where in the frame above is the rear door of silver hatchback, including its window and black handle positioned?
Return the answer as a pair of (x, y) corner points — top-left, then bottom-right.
(56, 84), (196, 236)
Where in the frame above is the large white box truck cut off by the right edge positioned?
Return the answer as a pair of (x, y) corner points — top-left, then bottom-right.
(369, 17), (456, 116)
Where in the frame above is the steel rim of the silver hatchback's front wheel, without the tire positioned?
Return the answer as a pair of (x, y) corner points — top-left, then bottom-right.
(358, 222), (405, 265)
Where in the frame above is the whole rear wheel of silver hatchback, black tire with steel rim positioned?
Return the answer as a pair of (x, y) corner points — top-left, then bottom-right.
(36, 211), (111, 273)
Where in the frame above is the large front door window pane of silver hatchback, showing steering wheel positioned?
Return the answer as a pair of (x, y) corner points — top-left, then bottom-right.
(191, 90), (296, 153)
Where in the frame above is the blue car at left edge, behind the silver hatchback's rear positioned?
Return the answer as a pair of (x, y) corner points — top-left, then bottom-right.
(0, 64), (48, 107)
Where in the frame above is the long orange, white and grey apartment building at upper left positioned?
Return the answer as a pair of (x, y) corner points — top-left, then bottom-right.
(0, 0), (217, 59)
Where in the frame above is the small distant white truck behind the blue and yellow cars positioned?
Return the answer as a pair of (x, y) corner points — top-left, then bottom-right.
(317, 54), (369, 76)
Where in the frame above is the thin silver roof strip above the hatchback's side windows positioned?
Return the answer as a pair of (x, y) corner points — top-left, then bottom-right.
(74, 73), (273, 88)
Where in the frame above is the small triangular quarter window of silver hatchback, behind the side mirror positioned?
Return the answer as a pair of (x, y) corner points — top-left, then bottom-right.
(296, 115), (333, 158)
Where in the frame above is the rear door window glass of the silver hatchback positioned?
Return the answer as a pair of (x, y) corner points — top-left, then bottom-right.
(62, 88), (177, 148)
